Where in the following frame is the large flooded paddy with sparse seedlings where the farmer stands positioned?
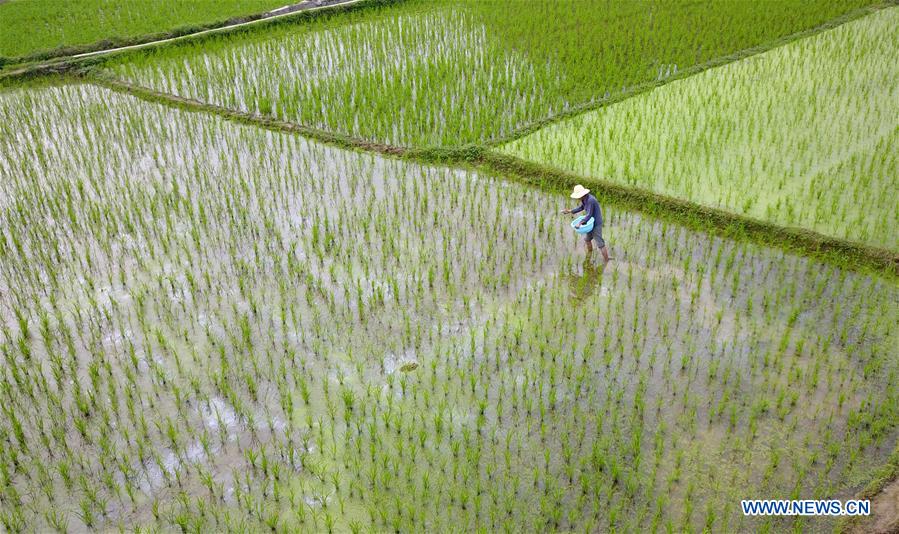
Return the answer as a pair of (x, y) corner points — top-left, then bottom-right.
(0, 84), (899, 532)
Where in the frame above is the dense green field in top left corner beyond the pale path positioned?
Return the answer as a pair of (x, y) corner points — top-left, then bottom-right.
(0, 0), (289, 58)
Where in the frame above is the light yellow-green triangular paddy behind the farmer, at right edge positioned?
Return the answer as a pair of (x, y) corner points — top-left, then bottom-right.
(502, 8), (899, 250)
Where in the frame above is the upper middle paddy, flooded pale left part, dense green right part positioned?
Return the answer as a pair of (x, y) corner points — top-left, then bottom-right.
(104, 0), (876, 146)
